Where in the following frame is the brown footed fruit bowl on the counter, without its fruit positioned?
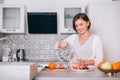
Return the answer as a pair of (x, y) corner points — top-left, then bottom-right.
(98, 67), (120, 76)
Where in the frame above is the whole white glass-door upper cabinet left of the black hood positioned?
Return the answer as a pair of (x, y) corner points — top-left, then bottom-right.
(0, 4), (26, 33)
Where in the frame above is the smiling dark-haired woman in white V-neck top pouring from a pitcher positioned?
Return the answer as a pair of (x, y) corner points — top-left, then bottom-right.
(56, 13), (103, 65)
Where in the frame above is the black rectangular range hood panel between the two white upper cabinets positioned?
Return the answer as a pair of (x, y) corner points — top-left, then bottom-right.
(27, 12), (57, 34)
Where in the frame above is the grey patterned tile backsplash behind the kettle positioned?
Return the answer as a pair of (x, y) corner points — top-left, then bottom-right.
(3, 34), (68, 61)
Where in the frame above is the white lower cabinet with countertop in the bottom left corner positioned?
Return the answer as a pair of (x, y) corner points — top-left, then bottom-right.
(0, 62), (38, 80)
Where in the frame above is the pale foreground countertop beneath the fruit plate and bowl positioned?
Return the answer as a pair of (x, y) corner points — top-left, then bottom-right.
(35, 68), (120, 80)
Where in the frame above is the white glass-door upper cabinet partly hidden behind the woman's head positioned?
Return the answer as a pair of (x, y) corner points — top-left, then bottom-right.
(58, 4), (85, 34)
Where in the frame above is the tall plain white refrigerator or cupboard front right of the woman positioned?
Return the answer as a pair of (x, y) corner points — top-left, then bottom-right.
(87, 1), (120, 62)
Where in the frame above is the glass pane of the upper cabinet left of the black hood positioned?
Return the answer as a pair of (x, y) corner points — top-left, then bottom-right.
(3, 8), (20, 29)
